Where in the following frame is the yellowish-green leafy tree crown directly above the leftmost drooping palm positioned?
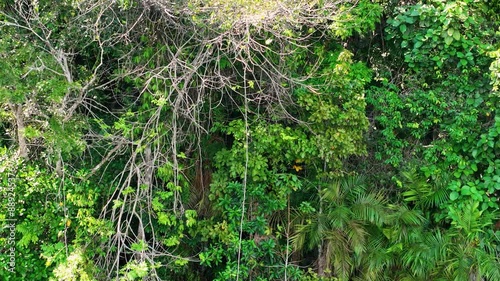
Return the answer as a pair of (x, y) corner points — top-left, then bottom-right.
(296, 47), (370, 167)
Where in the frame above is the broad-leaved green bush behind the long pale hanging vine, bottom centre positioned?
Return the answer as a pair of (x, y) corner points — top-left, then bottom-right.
(200, 120), (304, 280)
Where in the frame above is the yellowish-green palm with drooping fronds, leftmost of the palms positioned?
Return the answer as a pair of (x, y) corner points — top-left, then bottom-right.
(293, 176), (388, 280)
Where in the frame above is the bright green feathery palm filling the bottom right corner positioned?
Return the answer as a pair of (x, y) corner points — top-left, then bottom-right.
(399, 201), (500, 281)
